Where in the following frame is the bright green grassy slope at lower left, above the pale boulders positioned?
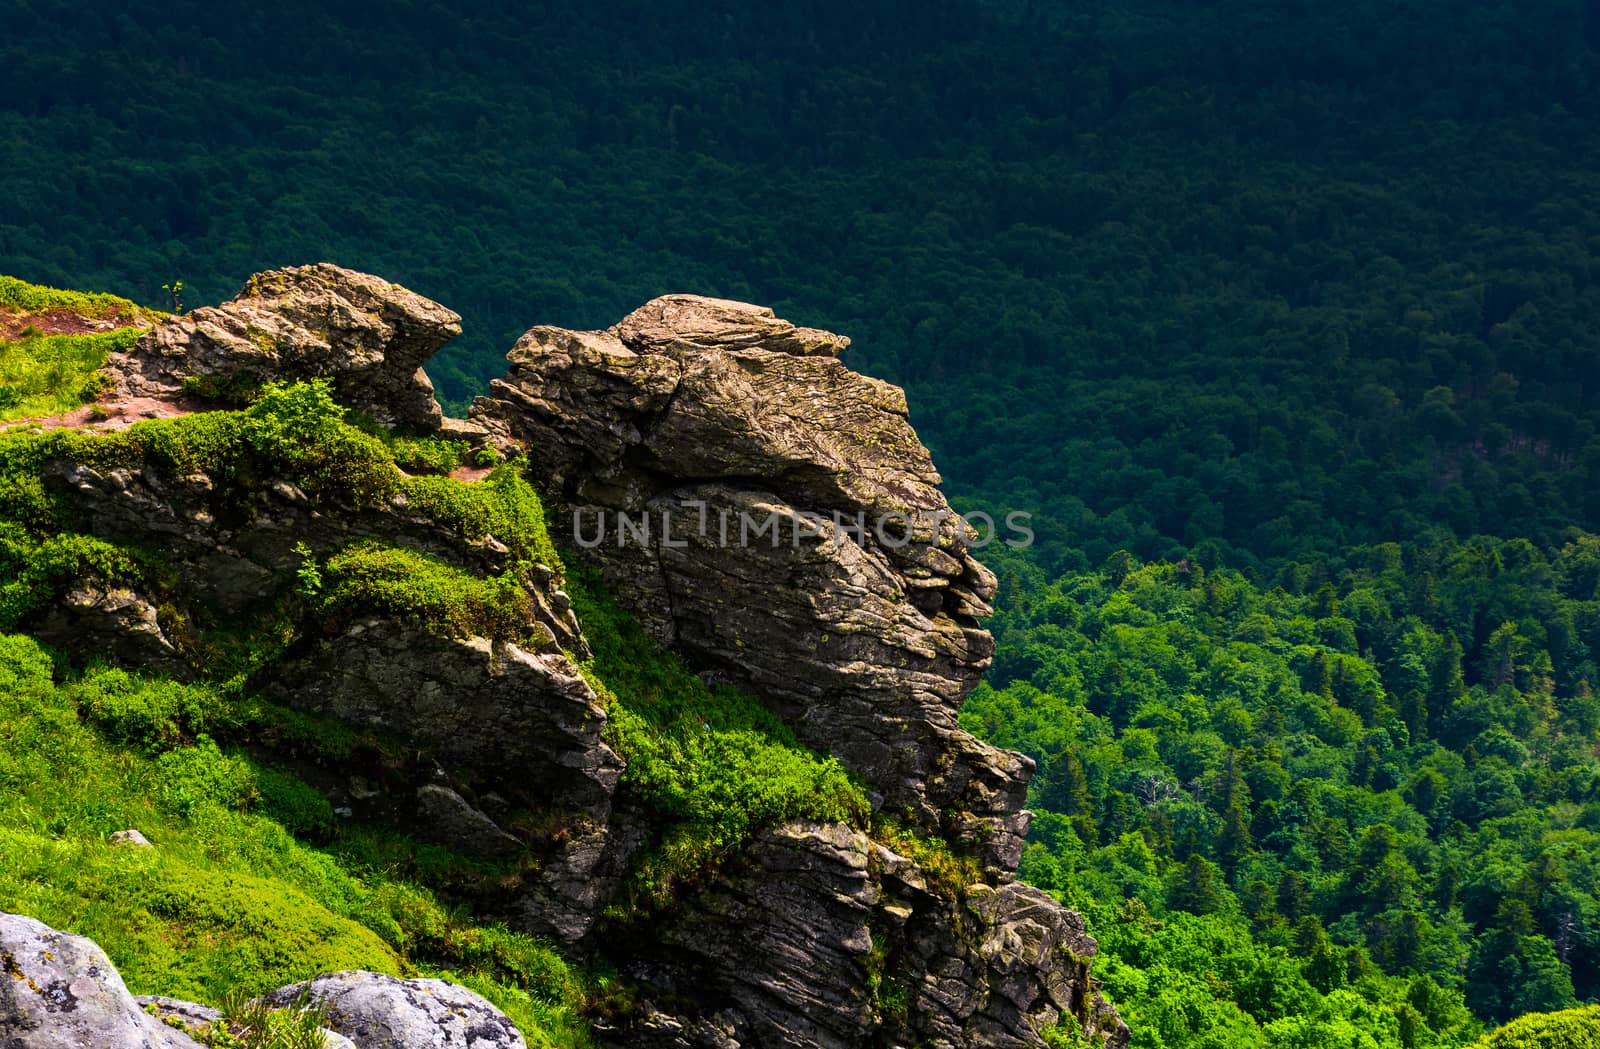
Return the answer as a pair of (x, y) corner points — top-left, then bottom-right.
(0, 635), (590, 1049)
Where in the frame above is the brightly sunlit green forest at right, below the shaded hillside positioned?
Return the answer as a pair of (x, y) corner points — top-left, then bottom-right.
(962, 531), (1600, 1046)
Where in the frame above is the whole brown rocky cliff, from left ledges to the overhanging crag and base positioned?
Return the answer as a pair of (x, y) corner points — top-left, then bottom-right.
(9, 265), (1126, 1049)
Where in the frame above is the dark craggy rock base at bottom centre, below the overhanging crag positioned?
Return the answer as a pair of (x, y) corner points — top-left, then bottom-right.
(618, 824), (1126, 1049)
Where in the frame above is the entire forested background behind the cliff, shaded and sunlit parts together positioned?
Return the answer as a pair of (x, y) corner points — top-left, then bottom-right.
(0, 0), (1600, 1049)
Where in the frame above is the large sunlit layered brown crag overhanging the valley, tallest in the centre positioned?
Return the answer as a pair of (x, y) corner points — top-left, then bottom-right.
(472, 296), (1032, 870)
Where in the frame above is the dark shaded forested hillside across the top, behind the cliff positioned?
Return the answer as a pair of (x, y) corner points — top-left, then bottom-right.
(0, 0), (1600, 568)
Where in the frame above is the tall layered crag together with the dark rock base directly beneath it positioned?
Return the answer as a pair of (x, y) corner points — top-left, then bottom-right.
(472, 296), (1126, 1049)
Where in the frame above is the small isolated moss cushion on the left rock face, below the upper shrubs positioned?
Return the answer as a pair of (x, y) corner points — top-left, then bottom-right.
(322, 542), (533, 641)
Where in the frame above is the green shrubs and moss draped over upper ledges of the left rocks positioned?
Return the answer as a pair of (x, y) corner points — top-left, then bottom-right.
(0, 381), (562, 640)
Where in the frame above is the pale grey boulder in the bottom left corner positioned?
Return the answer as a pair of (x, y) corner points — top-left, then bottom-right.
(0, 913), (198, 1049)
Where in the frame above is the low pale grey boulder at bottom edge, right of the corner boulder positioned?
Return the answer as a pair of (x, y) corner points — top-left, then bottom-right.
(262, 972), (526, 1049)
